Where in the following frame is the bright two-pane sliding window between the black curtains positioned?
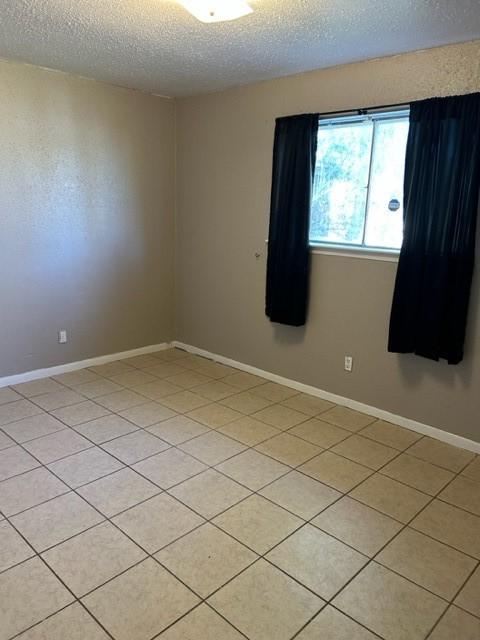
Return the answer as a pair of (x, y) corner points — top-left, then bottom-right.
(310, 109), (409, 250)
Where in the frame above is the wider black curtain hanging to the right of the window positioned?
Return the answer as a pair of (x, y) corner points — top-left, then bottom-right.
(388, 93), (480, 364)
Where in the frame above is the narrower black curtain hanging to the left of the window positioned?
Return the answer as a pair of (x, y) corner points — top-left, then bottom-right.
(265, 114), (318, 327)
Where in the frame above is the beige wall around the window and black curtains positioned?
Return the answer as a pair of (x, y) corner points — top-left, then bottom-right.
(176, 42), (480, 441)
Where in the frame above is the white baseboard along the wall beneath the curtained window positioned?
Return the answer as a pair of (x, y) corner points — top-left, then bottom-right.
(172, 340), (480, 453)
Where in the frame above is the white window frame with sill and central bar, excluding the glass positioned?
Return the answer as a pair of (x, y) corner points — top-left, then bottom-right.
(309, 104), (410, 262)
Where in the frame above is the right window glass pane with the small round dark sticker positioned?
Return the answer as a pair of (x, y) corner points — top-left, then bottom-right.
(365, 118), (409, 249)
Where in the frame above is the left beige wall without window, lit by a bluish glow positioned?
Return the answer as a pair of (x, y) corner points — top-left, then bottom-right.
(0, 62), (175, 377)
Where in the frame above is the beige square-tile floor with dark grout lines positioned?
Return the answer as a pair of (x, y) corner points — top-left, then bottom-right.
(0, 349), (480, 640)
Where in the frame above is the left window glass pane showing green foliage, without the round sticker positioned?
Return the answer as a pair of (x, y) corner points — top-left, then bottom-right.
(310, 121), (373, 244)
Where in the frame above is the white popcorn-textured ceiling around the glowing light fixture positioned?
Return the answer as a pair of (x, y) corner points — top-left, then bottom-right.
(0, 0), (480, 96)
